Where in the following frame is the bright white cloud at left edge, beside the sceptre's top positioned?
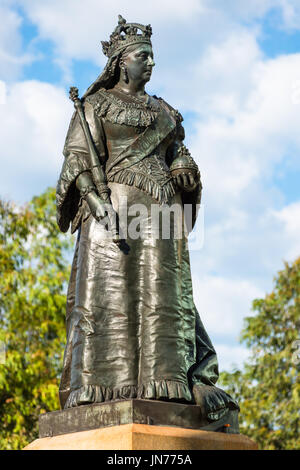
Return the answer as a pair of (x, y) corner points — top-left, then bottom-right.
(0, 81), (72, 201)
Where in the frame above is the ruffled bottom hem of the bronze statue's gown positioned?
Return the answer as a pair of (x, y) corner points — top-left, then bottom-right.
(65, 380), (193, 408)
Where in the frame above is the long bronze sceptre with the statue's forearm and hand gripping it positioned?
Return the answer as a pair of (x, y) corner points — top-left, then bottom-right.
(69, 87), (121, 244)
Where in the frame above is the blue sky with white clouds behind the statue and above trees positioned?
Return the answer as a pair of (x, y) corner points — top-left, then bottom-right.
(0, 0), (300, 369)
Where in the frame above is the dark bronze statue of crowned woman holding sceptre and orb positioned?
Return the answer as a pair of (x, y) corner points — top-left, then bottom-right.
(55, 16), (238, 429)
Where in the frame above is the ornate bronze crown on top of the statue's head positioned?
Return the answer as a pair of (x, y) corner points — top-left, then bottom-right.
(101, 15), (152, 58)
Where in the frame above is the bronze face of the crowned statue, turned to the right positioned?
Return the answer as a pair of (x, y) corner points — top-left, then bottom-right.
(123, 44), (155, 83)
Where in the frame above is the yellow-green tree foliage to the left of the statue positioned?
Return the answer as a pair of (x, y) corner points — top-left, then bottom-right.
(0, 189), (73, 449)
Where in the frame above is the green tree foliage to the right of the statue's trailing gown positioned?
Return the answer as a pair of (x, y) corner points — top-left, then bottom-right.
(222, 258), (300, 450)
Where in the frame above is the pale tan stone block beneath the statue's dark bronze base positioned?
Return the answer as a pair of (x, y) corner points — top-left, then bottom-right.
(24, 423), (257, 450)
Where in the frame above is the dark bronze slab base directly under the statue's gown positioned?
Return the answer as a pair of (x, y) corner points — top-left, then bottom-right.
(39, 399), (239, 438)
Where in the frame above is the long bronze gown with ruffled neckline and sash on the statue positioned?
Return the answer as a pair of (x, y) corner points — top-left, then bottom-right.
(57, 88), (218, 408)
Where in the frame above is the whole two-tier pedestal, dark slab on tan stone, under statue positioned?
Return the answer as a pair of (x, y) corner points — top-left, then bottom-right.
(25, 399), (257, 450)
